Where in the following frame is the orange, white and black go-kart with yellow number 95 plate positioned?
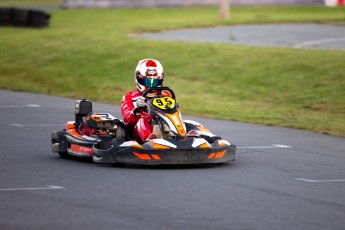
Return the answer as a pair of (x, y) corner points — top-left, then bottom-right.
(52, 87), (236, 165)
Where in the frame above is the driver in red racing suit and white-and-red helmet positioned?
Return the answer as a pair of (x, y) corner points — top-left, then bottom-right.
(121, 58), (171, 143)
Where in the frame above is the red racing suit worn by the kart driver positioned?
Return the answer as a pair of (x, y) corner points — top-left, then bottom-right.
(121, 89), (171, 143)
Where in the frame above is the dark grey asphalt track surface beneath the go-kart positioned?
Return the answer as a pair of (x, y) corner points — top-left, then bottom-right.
(0, 90), (345, 230)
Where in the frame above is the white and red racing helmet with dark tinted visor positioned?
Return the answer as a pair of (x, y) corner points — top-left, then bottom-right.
(134, 58), (164, 92)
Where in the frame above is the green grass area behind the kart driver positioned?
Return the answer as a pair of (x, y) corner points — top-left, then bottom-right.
(0, 4), (345, 137)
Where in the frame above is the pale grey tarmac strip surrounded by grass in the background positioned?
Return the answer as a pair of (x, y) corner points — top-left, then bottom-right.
(130, 23), (345, 50)
